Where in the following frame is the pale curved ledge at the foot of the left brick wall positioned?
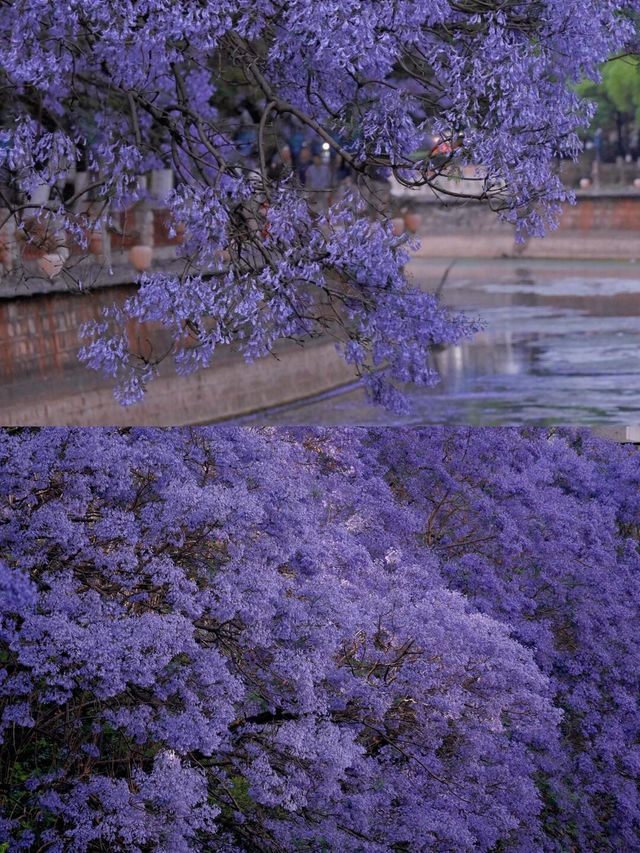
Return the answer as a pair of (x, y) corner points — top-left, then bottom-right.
(0, 332), (355, 426)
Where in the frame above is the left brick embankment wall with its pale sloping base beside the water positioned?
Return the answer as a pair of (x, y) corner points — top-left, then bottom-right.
(0, 274), (355, 426)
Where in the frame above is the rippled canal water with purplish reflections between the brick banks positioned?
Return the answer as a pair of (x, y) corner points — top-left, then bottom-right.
(240, 256), (640, 426)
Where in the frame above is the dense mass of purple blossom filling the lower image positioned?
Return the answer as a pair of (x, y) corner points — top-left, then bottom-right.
(0, 429), (640, 853)
